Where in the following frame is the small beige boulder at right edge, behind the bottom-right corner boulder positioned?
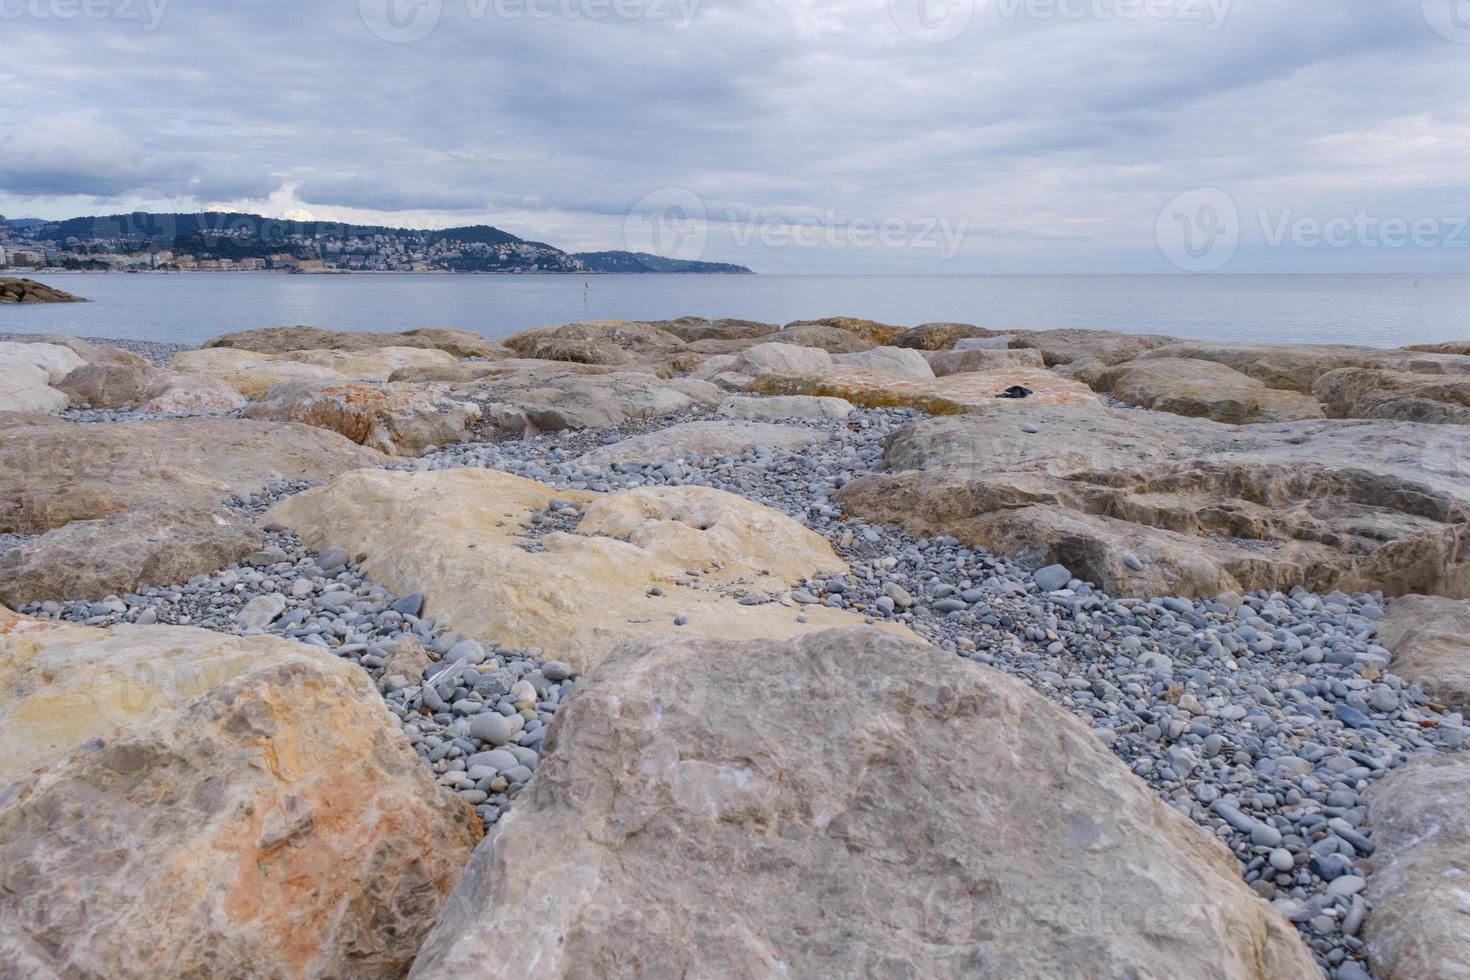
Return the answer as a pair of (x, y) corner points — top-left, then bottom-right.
(1377, 595), (1470, 710)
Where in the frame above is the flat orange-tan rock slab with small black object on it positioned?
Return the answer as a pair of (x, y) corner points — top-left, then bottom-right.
(750, 367), (1103, 416)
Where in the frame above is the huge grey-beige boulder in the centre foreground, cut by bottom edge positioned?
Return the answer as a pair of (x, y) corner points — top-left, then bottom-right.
(410, 630), (1320, 980)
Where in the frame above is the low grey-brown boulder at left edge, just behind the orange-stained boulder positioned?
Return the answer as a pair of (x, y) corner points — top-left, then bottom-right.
(0, 502), (260, 605)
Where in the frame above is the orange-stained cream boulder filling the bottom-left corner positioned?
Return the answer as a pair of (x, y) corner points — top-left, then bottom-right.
(0, 617), (479, 980)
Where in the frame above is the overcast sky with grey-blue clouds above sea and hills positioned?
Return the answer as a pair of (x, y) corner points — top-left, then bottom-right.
(0, 0), (1470, 273)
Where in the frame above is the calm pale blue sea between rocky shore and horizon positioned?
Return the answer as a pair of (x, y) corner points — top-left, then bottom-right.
(0, 273), (1470, 347)
